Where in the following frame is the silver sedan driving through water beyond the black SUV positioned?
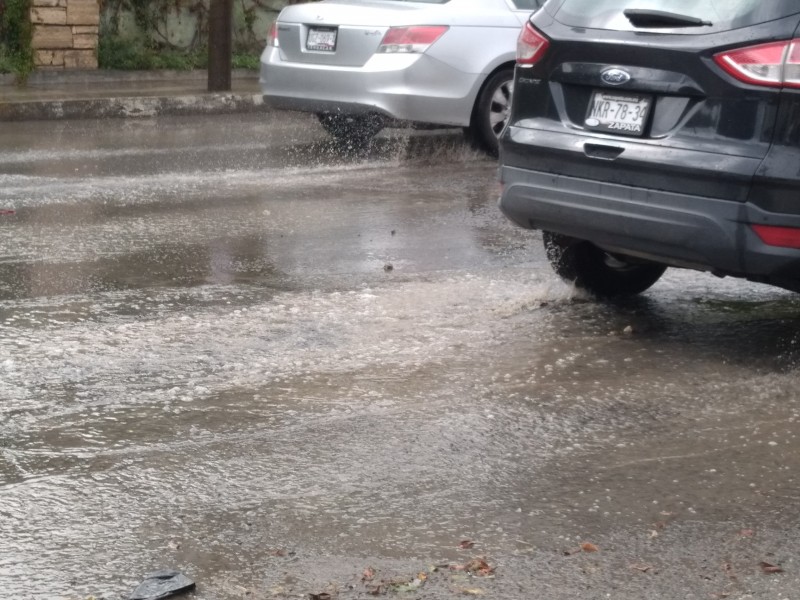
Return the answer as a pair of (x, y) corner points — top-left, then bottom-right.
(261, 0), (543, 154)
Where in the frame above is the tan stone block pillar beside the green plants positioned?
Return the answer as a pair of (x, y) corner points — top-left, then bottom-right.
(31, 0), (100, 69)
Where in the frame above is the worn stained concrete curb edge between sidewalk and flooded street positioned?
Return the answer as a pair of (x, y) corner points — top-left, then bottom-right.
(0, 93), (270, 121)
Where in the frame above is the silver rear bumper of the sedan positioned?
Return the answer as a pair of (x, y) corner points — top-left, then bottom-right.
(260, 47), (478, 126)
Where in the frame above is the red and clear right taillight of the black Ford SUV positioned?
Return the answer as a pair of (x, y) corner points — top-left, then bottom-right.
(714, 39), (800, 88)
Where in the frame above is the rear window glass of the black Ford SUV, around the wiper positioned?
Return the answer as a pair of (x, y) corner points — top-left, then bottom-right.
(554, 0), (800, 32)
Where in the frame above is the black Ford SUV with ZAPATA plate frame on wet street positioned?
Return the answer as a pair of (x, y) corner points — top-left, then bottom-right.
(500, 0), (800, 296)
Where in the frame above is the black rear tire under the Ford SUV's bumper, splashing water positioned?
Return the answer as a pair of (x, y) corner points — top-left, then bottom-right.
(543, 231), (667, 298)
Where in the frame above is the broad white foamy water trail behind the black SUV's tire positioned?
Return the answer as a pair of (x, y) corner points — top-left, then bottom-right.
(0, 276), (568, 415)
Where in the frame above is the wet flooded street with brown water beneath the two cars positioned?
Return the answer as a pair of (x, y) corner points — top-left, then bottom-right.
(0, 114), (800, 600)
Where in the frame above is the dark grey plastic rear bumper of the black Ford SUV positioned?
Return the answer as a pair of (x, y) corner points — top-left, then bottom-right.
(500, 166), (800, 289)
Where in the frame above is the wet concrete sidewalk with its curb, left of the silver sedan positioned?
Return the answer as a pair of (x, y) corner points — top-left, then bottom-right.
(0, 70), (269, 121)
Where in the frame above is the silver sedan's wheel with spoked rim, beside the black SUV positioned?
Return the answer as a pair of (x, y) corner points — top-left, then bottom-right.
(466, 68), (514, 156)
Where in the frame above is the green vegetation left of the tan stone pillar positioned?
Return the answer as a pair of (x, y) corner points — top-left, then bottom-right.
(0, 0), (33, 83)
